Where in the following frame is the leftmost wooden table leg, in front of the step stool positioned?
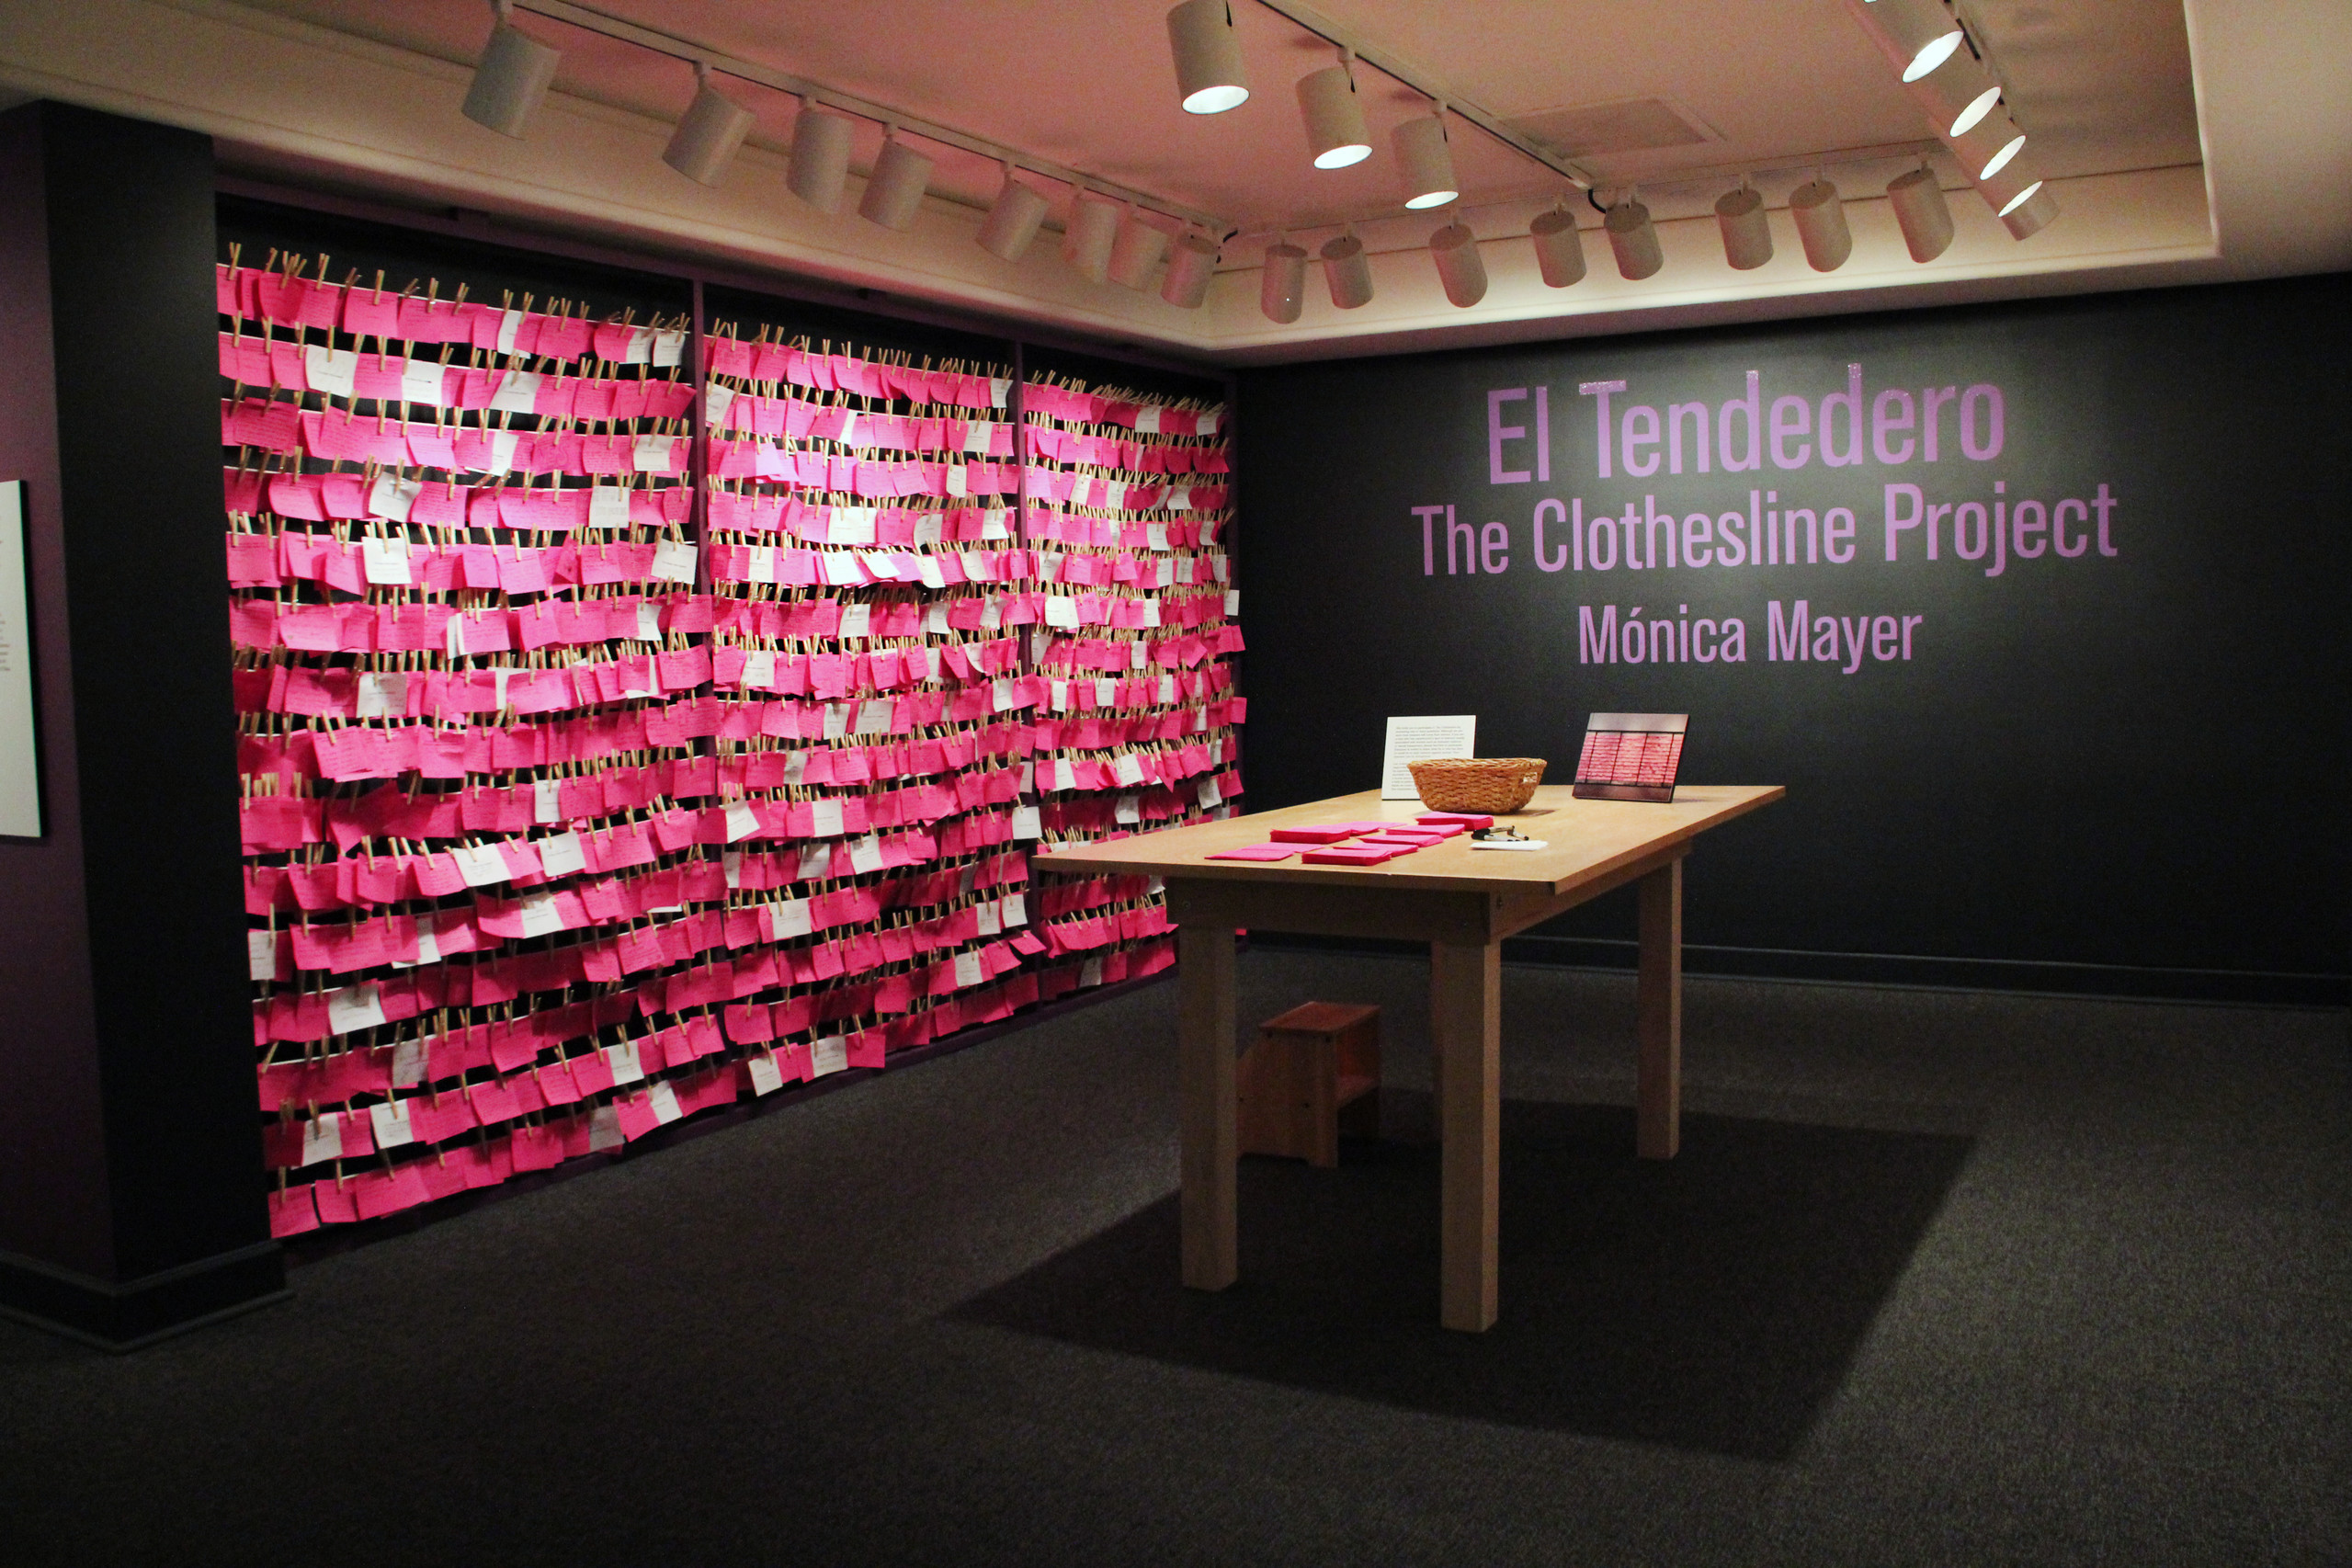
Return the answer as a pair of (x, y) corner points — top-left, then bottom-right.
(1176, 926), (1240, 1290)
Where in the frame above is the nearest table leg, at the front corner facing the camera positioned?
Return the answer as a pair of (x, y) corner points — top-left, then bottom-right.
(1430, 943), (1503, 1333)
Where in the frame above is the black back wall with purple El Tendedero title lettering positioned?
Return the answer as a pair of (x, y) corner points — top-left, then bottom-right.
(1237, 275), (2352, 996)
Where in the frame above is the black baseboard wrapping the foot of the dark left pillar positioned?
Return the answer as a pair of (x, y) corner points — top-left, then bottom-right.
(0, 1241), (290, 1352)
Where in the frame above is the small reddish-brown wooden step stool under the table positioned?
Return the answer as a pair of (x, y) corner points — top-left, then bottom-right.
(1237, 1002), (1381, 1166)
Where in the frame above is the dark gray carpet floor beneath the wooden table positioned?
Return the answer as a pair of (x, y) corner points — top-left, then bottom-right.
(0, 949), (2352, 1568)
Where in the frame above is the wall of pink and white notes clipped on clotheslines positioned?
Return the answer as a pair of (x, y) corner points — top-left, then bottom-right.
(219, 254), (1244, 1236)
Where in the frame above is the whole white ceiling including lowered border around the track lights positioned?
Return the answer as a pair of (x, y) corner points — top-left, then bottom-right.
(0, 0), (2352, 362)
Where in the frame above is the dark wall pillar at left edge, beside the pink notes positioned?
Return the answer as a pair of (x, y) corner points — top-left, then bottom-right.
(0, 104), (285, 1345)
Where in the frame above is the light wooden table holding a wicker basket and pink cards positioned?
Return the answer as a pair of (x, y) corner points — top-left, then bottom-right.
(1035, 785), (1788, 1333)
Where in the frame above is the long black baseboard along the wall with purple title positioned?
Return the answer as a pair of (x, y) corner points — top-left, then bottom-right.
(1251, 931), (2352, 1006)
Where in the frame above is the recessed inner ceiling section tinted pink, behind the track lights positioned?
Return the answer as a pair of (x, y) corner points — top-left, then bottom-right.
(238, 0), (2199, 231)
